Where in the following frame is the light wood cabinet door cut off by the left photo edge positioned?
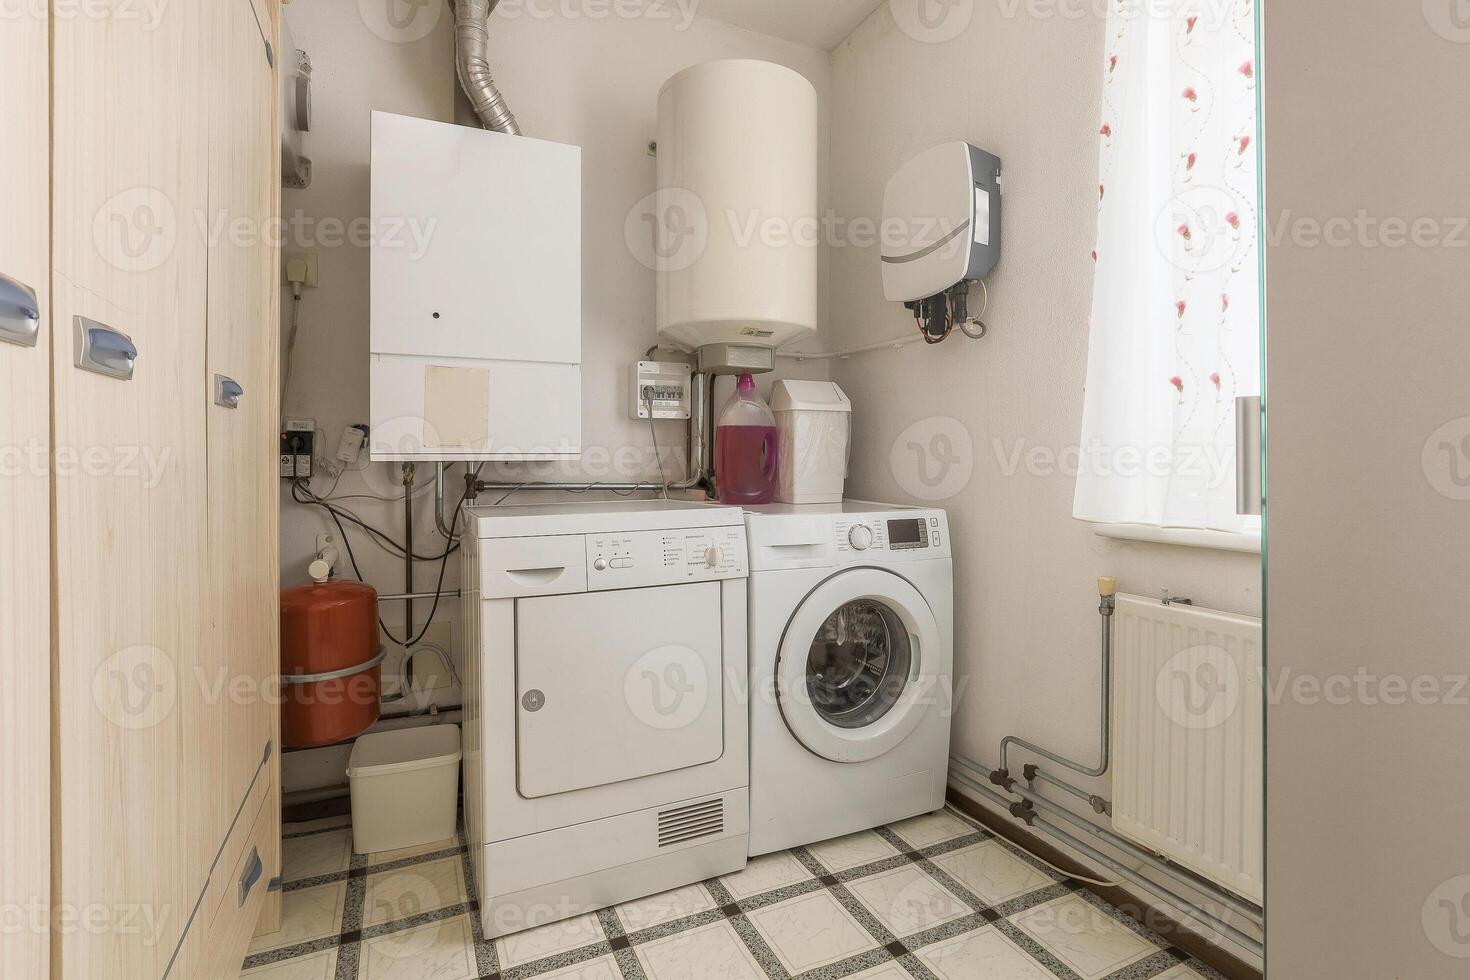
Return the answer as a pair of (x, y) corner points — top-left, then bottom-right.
(0, 9), (51, 977)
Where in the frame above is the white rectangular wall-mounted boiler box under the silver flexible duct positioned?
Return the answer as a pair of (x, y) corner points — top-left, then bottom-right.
(370, 112), (582, 461)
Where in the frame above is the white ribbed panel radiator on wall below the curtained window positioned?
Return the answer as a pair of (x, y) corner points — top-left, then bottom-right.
(1113, 595), (1264, 902)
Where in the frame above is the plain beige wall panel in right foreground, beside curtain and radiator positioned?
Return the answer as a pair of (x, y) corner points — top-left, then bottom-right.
(1264, 0), (1470, 980)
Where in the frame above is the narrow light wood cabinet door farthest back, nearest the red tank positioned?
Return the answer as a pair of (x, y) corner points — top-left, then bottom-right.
(203, 0), (281, 880)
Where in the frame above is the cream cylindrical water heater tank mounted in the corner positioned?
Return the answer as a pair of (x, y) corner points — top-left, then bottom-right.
(650, 60), (822, 373)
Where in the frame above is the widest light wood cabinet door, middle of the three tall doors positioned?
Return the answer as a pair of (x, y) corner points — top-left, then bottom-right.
(51, 0), (210, 980)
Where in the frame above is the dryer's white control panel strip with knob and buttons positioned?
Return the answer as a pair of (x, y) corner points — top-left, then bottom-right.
(587, 526), (750, 592)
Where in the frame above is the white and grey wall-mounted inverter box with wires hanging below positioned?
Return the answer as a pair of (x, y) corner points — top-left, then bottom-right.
(882, 143), (1001, 307)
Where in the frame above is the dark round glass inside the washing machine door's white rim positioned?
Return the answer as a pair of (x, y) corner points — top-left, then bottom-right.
(807, 598), (914, 729)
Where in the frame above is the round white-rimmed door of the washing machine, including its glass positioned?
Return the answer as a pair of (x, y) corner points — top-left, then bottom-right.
(776, 569), (947, 763)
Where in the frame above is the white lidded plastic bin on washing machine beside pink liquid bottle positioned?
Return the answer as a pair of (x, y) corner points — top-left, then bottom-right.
(770, 381), (853, 504)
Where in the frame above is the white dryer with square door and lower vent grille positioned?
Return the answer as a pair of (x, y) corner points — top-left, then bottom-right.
(462, 501), (750, 937)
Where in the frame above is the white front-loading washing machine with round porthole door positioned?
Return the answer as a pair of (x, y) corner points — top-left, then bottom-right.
(745, 501), (954, 857)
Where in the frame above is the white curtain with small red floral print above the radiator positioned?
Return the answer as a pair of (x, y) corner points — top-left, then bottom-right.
(1073, 0), (1260, 532)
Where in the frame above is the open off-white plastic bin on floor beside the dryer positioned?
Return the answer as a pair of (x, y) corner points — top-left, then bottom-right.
(347, 724), (462, 854)
